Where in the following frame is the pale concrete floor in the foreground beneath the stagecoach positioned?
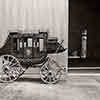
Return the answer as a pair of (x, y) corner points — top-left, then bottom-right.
(0, 74), (100, 100)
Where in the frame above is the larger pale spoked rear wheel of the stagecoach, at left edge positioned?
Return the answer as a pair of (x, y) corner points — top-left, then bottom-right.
(0, 55), (21, 82)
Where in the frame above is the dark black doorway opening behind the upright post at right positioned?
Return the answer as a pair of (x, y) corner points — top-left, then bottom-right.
(68, 0), (100, 67)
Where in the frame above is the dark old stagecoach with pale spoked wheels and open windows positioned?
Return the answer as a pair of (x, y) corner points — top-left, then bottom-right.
(0, 32), (66, 83)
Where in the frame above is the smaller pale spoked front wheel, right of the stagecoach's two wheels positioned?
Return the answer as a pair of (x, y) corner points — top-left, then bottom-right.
(40, 57), (61, 84)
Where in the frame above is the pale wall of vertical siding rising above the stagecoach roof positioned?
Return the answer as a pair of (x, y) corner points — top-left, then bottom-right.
(0, 0), (68, 68)
